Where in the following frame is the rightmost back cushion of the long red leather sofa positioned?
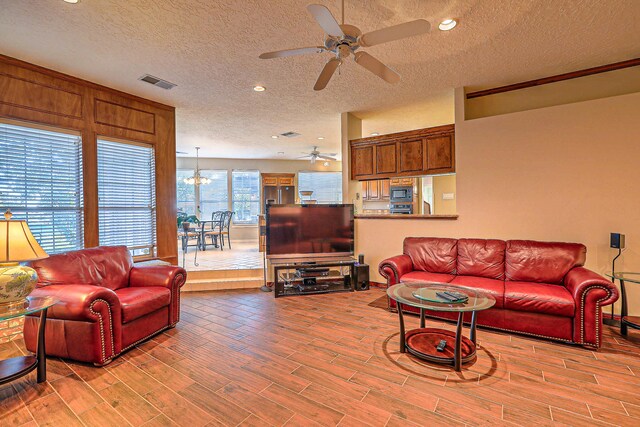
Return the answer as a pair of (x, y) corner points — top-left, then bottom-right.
(505, 240), (587, 285)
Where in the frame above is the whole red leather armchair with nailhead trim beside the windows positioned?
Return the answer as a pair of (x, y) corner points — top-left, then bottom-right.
(24, 246), (187, 365)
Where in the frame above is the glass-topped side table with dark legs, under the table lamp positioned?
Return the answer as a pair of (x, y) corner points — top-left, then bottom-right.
(0, 297), (58, 384)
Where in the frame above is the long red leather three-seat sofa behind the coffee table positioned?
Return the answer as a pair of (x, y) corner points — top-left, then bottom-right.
(379, 237), (618, 348)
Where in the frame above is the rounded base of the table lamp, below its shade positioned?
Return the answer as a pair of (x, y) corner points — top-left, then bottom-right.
(0, 263), (38, 311)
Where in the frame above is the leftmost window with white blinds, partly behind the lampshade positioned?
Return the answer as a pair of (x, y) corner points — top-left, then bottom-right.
(0, 123), (84, 254)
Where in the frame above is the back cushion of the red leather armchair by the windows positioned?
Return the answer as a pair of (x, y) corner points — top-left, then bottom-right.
(31, 246), (133, 290)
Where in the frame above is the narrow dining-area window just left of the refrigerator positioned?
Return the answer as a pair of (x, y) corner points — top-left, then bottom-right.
(231, 170), (260, 224)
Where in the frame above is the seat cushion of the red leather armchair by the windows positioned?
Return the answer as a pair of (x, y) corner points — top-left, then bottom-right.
(115, 286), (171, 323)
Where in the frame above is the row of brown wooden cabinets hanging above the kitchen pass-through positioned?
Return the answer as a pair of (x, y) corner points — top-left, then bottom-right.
(349, 125), (455, 181)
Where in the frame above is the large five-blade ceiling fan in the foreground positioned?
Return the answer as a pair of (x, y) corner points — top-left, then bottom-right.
(260, 0), (431, 90)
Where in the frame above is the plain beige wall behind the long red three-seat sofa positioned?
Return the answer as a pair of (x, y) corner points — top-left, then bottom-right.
(356, 90), (640, 314)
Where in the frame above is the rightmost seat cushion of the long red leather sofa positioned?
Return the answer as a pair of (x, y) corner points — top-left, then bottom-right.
(504, 282), (576, 317)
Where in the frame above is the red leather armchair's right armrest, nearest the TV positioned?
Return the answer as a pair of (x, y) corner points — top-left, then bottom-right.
(129, 265), (187, 327)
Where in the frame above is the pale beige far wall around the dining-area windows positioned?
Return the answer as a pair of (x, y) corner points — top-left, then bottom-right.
(177, 158), (342, 240)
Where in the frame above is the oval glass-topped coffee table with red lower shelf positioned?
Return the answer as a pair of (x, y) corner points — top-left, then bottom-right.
(387, 282), (496, 371)
